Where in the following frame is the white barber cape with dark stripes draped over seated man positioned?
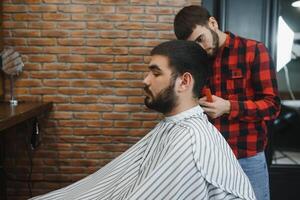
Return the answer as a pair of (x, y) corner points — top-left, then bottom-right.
(29, 106), (255, 200)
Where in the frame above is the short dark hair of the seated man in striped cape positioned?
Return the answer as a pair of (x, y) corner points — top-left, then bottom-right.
(151, 40), (210, 98)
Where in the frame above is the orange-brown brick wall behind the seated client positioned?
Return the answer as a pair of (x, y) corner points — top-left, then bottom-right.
(2, 0), (201, 199)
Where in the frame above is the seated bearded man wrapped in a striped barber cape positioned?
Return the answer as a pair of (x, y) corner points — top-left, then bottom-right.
(29, 41), (255, 200)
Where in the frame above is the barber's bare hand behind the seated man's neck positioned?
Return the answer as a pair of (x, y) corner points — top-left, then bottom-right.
(199, 95), (230, 119)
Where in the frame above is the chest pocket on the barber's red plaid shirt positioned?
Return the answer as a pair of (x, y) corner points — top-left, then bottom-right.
(226, 68), (246, 100)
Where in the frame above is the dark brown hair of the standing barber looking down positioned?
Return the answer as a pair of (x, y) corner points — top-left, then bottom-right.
(174, 5), (211, 40)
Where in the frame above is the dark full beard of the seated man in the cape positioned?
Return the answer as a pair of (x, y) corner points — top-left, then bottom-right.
(144, 81), (178, 114)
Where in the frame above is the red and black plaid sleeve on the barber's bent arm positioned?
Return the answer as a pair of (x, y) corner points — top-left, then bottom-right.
(229, 43), (280, 122)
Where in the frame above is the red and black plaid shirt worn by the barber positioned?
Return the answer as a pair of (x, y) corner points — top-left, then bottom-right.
(208, 33), (280, 158)
